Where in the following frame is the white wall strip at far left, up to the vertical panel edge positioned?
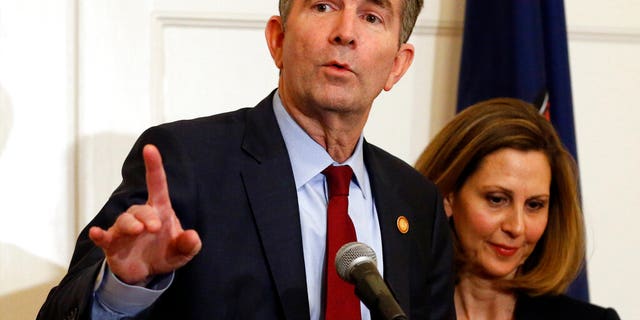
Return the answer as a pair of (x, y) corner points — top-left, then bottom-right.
(0, 0), (76, 319)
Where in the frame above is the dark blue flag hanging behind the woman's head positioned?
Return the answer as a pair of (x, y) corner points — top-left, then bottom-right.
(457, 0), (589, 301)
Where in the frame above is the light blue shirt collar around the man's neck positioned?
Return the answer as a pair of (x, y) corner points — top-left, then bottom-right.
(273, 92), (368, 198)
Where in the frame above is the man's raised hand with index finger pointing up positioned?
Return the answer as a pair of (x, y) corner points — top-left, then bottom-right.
(89, 145), (202, 284)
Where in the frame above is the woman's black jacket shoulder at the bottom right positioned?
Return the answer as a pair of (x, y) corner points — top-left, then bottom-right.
(514, 295), (620, 320)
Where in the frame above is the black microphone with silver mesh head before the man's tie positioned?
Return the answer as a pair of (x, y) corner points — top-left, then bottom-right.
(335, 242), (407, 320)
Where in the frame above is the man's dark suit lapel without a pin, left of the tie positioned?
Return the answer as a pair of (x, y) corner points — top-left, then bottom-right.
(241, 94), (309, 319)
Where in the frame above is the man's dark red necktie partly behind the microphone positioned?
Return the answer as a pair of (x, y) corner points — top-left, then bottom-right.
(322, 166), (360, 320)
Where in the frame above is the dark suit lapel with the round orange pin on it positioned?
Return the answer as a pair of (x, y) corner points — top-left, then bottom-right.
(364, 143), (413, 312)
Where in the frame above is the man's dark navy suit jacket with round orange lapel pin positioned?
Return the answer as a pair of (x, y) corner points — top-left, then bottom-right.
(39, 93), (454, 319)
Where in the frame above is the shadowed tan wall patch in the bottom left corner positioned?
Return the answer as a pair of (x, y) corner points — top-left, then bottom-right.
(0, 243), (66, 320)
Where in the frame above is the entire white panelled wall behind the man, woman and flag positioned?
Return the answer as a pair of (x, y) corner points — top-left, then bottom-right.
(0, 0), (640, 319)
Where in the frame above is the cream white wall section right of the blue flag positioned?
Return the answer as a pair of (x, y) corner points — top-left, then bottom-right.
(565, 0), (640, 319)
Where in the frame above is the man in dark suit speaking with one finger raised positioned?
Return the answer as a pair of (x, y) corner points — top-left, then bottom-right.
(38, 0), (454, 319)
